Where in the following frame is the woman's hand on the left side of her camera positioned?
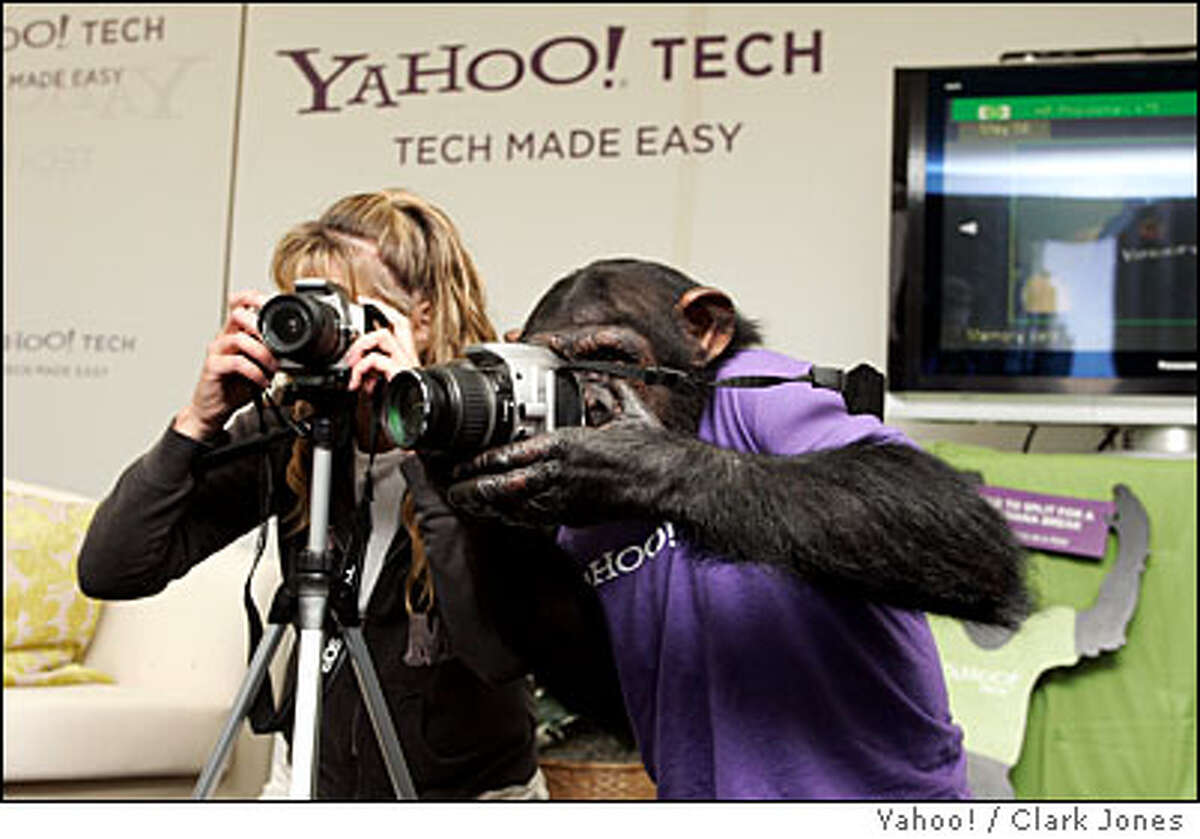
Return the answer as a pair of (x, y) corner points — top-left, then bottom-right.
(174, 289), (280, 441)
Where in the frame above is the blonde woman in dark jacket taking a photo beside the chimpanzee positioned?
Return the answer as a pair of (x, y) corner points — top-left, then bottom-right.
(79, 191), (545, 799)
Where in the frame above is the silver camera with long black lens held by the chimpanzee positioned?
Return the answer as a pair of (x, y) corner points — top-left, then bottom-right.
(380, 343), (586, 454)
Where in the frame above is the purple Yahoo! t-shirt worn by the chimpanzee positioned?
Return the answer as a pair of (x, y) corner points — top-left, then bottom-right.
(559, 349), (968, 799)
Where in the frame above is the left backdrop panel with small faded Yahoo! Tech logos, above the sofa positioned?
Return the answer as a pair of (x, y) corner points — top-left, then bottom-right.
(4, 5), (241, 495)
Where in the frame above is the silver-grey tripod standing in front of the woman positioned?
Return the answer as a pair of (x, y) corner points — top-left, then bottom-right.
(192, 416), (416, 799)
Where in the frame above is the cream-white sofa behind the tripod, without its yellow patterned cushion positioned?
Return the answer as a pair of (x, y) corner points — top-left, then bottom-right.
(4, 481), (284, 798)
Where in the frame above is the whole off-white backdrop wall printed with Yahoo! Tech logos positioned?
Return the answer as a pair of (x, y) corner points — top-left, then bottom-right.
(5, 4), (1195, 492)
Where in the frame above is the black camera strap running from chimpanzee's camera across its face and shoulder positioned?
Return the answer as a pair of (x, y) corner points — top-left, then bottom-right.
(564, 361), (884, 420)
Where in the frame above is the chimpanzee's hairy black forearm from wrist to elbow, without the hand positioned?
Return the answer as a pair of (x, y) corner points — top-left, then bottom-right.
(661, 432), (1028, 625)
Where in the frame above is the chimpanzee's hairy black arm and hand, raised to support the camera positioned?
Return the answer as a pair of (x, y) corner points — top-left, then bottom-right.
(449, 419), (1028, 625)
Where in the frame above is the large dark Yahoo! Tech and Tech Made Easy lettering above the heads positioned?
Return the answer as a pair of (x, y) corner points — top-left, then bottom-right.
(268, 25), (824, 166)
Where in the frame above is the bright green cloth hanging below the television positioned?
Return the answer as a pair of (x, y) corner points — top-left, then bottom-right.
(924, 442), (1196, 801)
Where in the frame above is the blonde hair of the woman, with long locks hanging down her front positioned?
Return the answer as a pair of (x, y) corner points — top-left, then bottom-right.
(271, 190), (496, 612)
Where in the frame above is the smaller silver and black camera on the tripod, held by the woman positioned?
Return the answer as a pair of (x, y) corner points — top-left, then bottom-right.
(258, 280), (388, 389)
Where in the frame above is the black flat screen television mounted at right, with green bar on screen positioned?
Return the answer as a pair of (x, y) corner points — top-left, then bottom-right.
(888, 58), (1196, 425)
